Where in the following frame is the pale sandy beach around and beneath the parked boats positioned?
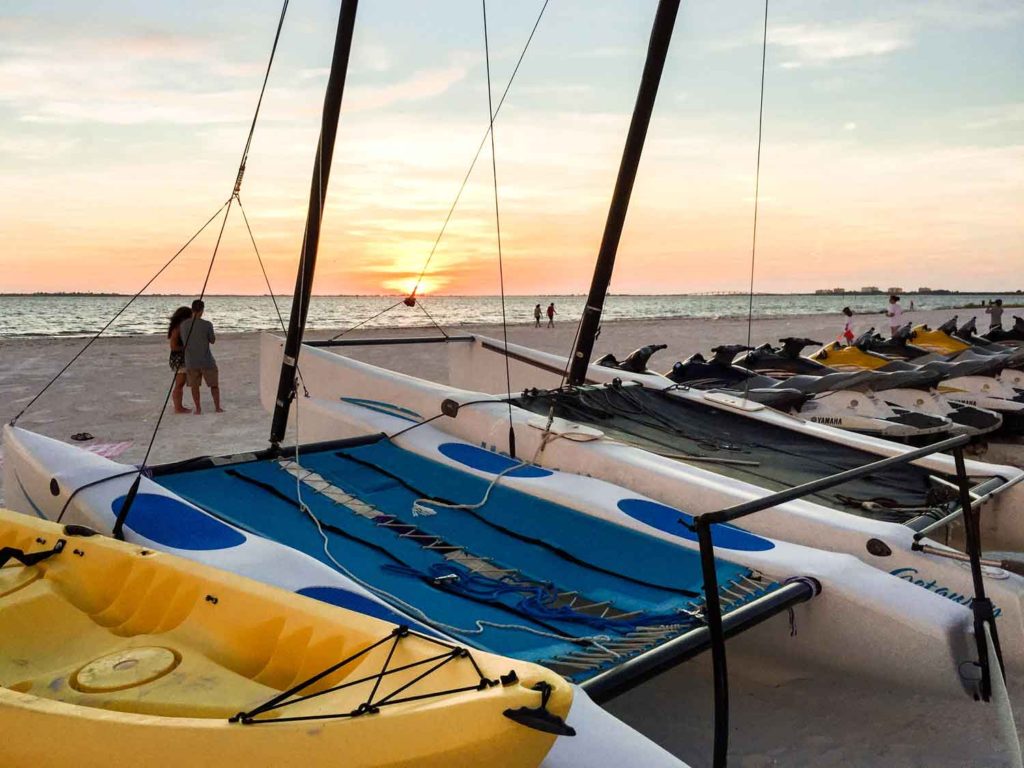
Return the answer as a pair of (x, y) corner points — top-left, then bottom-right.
(0, 306), (1024, 768)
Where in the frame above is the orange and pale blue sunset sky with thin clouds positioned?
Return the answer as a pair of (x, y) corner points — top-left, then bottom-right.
(0, 0), (1024, 295)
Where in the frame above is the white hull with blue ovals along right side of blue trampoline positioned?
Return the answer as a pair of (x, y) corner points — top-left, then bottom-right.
(276, 393), (987, 691)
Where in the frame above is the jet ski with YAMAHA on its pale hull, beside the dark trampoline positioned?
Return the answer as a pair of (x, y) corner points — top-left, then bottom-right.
(655, 344), (953, 437)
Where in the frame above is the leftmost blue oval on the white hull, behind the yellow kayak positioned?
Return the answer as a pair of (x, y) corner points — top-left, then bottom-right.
(111, 494), (246, 551)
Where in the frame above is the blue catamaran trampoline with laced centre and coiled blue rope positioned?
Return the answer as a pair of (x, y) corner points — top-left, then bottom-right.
(157, 439), (777, 681)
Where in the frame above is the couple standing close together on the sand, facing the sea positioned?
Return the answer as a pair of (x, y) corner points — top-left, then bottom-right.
(167, 299), (224, 415)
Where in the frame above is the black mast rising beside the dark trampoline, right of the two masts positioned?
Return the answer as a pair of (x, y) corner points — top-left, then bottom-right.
(569, 0), (679, 386)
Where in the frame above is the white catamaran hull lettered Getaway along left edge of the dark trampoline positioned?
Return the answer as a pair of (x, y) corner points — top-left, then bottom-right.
(253, 336), (1024, 675)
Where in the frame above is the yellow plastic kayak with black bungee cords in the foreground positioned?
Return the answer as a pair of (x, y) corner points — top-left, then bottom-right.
(0, 510), (572, 768)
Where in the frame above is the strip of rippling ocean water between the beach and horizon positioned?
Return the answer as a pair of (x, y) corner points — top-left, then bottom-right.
(0, 294), (1007, 337)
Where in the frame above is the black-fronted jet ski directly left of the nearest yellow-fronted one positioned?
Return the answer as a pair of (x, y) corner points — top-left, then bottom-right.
(735, 337), (1002, 436)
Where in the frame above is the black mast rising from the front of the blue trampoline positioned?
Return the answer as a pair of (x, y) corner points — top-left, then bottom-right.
(270, 0), (358, 445)
